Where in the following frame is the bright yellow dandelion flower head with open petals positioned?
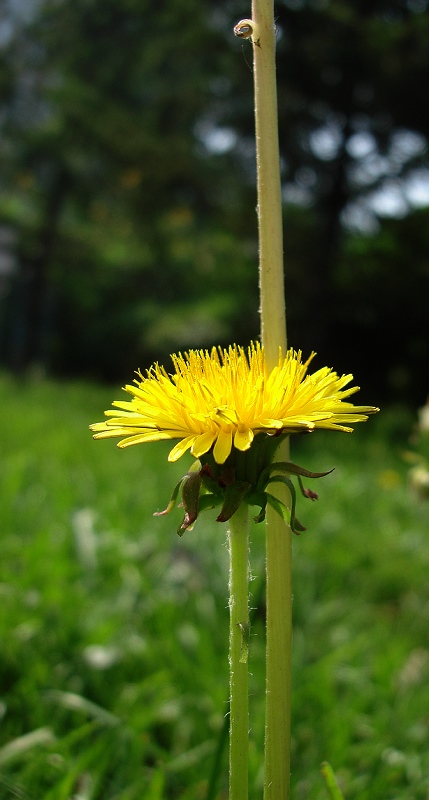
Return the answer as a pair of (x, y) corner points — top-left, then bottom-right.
(91, 342), (378, 464)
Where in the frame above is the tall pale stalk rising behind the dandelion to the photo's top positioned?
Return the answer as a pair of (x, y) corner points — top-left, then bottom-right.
(252, 0), (292, 800)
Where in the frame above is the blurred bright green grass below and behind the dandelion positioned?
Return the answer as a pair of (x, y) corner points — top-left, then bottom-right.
(0, 376), (429, 800)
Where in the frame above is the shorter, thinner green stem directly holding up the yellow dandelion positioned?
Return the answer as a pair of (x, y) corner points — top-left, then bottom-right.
(228, 503), (249, 800)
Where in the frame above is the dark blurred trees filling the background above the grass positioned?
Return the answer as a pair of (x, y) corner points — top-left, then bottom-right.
(0, 0), (429, 401)
